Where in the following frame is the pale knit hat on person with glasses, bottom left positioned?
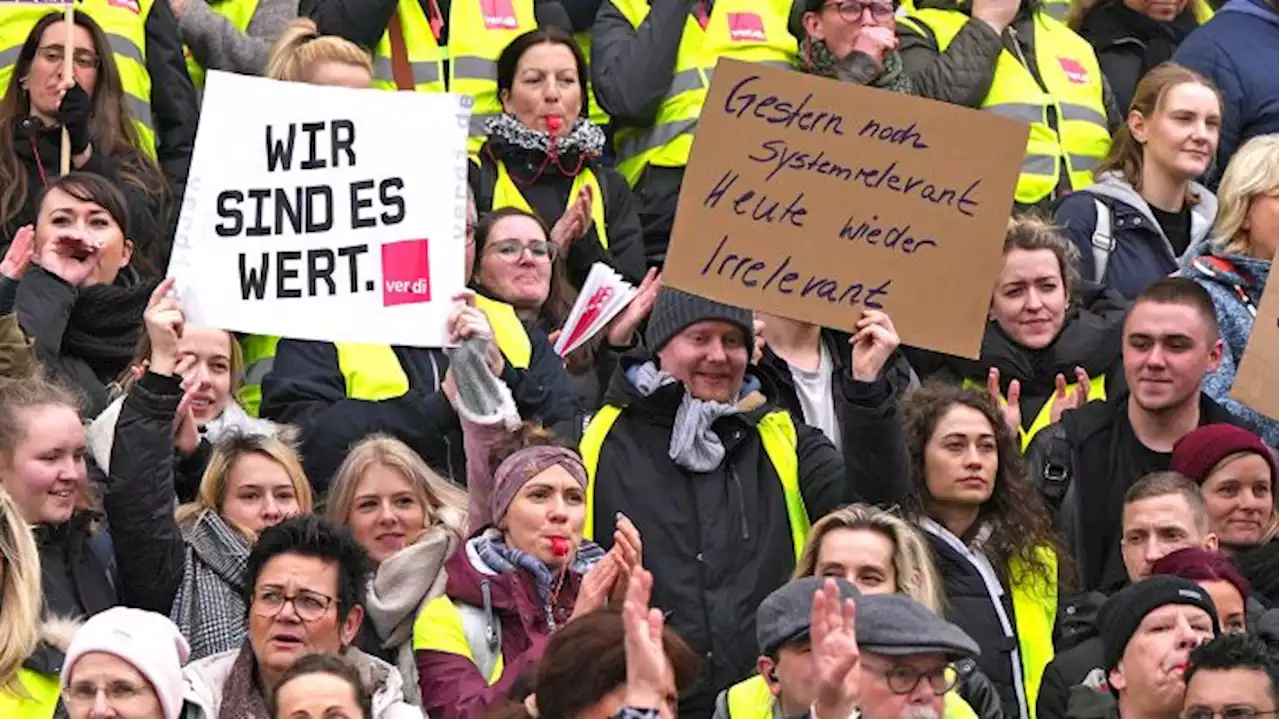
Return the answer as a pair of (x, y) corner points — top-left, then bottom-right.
(63, 606), (191, 719)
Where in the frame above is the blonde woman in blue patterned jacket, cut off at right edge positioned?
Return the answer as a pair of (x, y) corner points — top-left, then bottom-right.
(1179, 134), (1280, 446)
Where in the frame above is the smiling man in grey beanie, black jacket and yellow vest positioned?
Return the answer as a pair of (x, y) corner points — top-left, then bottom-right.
(567, 288), (910, 719)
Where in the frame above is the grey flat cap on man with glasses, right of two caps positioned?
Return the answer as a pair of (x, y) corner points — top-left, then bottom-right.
(858, 594), (979, 660)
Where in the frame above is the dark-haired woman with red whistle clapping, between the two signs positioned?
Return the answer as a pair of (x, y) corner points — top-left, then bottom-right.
(470, 26), (645, 288)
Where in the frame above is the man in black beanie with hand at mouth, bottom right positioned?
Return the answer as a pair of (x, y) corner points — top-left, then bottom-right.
(1068, 576), (1220, 719)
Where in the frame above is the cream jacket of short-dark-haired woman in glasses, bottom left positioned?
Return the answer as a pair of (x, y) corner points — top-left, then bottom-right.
(182, 647), (409, 719)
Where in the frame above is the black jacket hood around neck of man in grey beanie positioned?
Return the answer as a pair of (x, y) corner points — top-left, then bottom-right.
(604, 349), (778, 426)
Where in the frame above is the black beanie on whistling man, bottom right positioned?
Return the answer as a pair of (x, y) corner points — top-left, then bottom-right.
(1098, 574), (1220, 672)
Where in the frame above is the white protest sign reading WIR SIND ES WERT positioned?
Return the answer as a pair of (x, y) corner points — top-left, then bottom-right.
(169, 72), (471, 347)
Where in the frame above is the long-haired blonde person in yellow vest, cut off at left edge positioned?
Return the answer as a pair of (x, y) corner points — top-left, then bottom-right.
(0, 490), (59, 716)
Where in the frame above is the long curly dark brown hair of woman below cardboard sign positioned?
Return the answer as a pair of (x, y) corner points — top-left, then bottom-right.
(902, 381), (1075, 586)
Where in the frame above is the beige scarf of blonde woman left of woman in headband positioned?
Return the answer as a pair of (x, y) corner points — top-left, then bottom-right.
(365, 525), (458, 647)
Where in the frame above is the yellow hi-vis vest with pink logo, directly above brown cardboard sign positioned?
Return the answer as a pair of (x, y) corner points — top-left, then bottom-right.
(611, 0), (796, 187)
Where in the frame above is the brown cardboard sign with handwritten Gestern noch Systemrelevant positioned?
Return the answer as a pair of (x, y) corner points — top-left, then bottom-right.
(662, 59), (1028, 358)
